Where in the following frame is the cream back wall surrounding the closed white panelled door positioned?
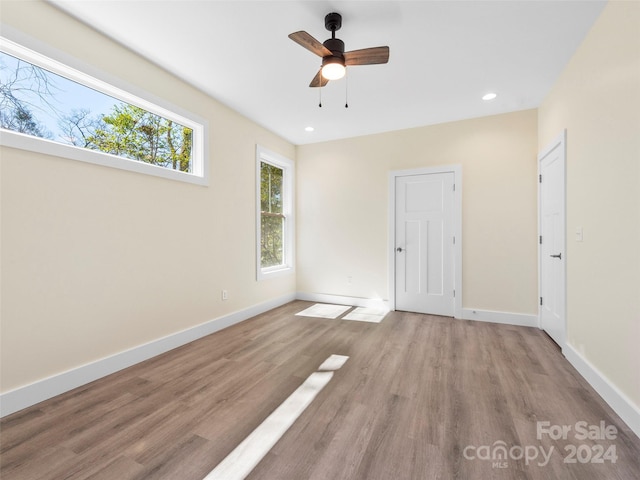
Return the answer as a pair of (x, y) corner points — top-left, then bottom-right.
(297, 110), (537, 314)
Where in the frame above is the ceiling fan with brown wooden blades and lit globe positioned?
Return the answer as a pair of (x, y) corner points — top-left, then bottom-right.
(289, 12), (389, 87)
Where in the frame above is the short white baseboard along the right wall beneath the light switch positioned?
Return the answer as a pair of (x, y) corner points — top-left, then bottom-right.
(562, 342), (640, 438)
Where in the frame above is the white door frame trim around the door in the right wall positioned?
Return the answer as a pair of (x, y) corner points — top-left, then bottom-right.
(537, 129), (568, 349)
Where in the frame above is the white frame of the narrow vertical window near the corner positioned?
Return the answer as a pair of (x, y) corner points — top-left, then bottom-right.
(256, 145), (295, 281)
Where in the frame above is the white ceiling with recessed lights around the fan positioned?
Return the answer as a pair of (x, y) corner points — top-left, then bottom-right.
(51, 0), (606, 145)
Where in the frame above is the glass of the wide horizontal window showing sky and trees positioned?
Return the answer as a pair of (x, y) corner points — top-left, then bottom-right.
(0, 52), (193, 172)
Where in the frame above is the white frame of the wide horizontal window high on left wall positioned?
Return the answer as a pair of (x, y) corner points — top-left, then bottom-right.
(0, 34), (209, 186)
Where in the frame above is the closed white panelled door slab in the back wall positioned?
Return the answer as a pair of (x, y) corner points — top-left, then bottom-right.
(395, 172), (455, 316)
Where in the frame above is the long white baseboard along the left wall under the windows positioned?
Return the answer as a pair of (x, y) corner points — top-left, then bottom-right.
(0, 294), (296, 417)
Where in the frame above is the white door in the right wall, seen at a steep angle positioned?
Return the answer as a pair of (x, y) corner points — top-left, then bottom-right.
(538, 135), (566, 347)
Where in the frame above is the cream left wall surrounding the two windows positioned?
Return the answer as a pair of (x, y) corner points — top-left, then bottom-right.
(0, 2), (295, 392)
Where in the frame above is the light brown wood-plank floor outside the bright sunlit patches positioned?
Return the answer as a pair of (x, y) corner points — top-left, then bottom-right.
(0, 301), (640, 480)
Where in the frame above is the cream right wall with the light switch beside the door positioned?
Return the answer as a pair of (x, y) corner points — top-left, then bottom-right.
(539, 2), (640, 407)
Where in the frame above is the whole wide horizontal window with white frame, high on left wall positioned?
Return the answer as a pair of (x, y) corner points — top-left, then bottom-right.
(0, 39), (206, 184)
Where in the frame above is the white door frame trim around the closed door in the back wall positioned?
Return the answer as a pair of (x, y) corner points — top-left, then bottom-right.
(387, 165), (462, 318)
